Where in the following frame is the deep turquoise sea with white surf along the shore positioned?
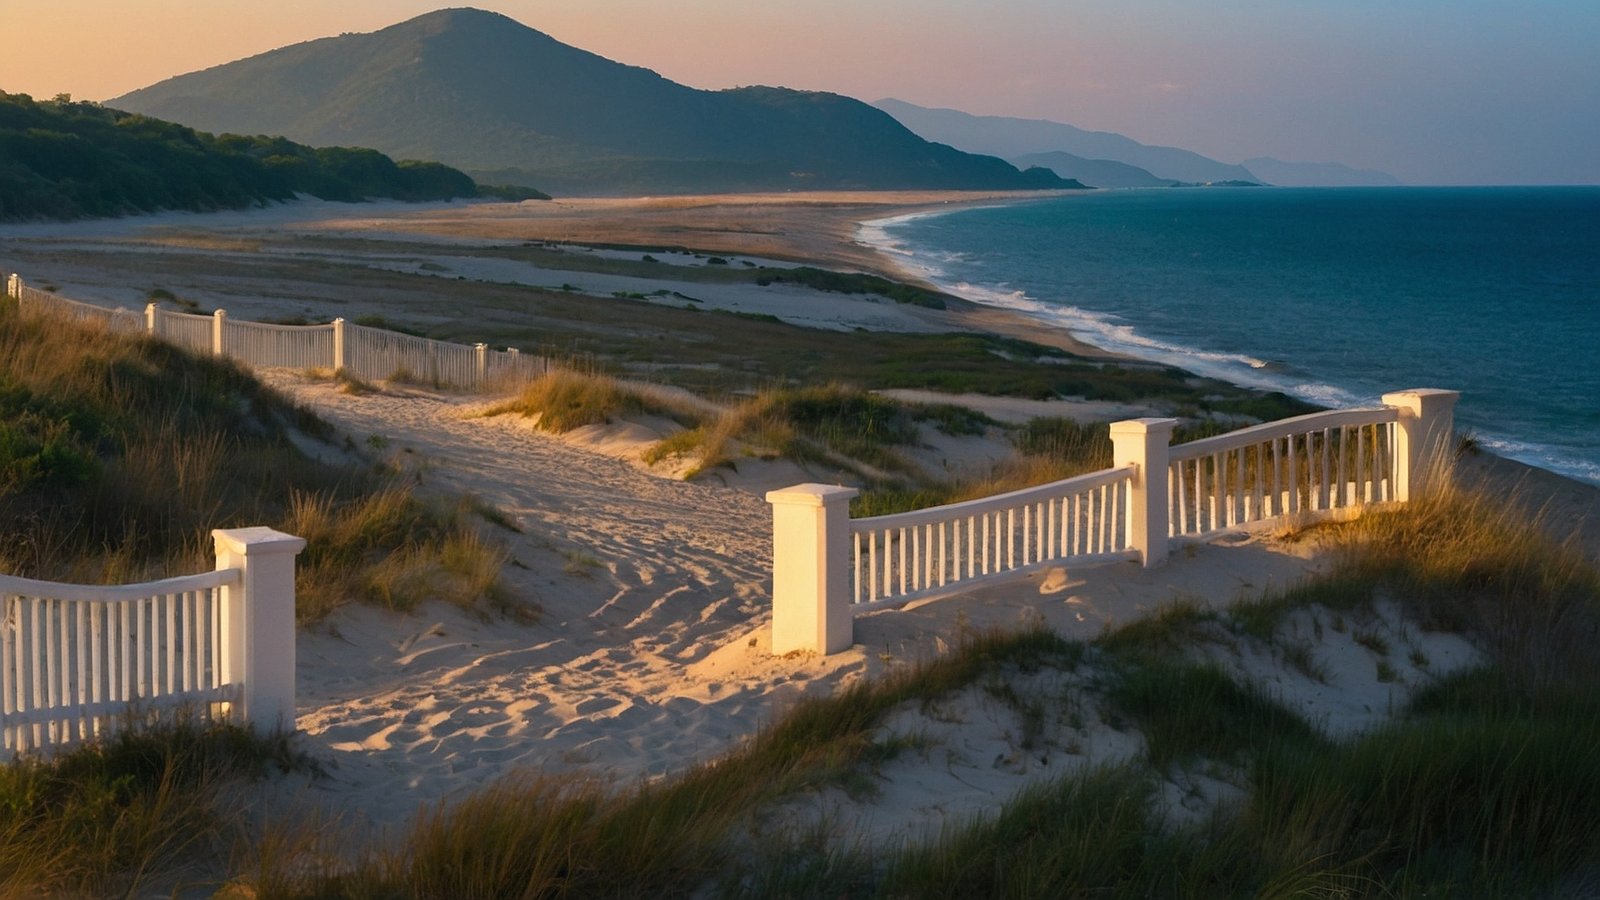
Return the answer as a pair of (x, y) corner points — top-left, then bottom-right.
(862, 187), (1600, 484)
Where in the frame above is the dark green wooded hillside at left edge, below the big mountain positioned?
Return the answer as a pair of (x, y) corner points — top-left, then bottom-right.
(0, 91), (515, 221)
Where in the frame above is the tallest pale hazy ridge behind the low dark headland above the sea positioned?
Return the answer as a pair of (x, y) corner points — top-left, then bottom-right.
(872, 99), (1261, 184)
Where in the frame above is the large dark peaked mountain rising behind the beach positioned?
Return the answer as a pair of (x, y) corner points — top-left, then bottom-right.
(116, 10), (1072, 194)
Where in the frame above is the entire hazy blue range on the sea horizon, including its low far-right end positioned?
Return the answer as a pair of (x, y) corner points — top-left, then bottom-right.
(872, 98), (1400, 187)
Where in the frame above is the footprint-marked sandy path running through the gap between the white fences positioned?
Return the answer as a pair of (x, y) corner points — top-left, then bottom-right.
(278, 380), (835, 822)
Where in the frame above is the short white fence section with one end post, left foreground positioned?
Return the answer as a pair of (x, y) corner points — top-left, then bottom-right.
(0, 528), (306, 754)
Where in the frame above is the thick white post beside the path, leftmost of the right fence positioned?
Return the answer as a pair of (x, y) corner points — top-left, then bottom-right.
(766, 484), (861, 655)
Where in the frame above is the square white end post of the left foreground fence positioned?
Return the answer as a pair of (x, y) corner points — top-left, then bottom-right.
(211, 527), (306, 733)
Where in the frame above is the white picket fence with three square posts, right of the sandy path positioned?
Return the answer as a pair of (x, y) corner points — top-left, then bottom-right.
(766, 389), (1458, 653)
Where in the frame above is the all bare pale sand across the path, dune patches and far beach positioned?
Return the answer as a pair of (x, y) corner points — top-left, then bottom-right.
(0, 194), (1600, 841)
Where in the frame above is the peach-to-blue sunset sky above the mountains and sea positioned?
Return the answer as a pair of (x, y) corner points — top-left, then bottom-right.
(0, 0), (1600, 184)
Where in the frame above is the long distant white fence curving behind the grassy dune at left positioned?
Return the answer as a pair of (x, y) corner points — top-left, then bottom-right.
(6, 275), (549, 391)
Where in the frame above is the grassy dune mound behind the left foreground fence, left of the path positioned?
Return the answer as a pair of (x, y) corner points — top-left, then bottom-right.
(0, 303), (506, 621)
